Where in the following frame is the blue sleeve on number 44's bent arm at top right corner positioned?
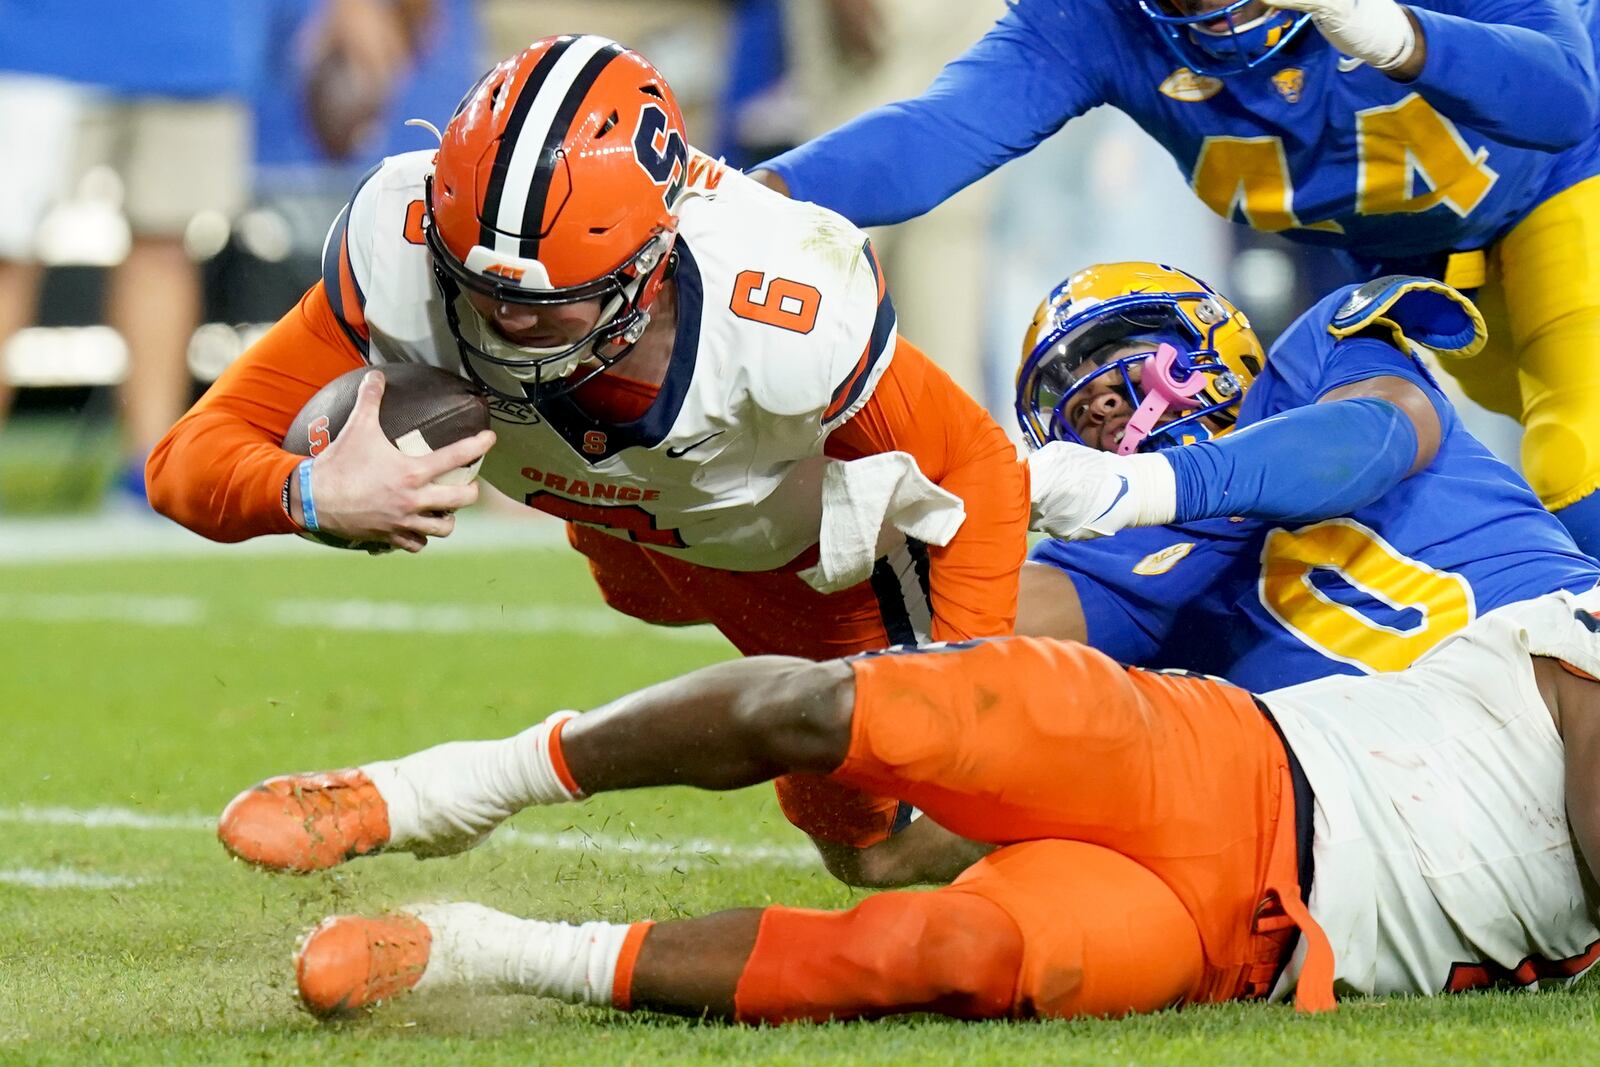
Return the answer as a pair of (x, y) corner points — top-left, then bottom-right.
(1411, 0), (1600, 152)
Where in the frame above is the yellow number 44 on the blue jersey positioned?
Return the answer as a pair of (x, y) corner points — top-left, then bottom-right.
(1192, 93), (1499, 234)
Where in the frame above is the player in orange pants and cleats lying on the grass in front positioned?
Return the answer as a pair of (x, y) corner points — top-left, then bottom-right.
(219, 592), (1600, 1022)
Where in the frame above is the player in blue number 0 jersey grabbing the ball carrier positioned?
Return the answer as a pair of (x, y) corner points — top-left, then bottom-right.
(1018, 262), (1600, 691)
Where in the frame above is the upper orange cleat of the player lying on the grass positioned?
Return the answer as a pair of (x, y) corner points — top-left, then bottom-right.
(216, 769), (389, 873)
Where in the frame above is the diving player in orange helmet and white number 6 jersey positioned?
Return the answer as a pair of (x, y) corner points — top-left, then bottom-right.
(149, 35), (1027, 863)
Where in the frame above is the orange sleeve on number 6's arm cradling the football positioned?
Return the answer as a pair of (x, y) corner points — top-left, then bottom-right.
(144, 283), (365, 541)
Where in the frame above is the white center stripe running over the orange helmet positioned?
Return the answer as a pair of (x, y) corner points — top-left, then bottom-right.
(483, 35), (618, 256)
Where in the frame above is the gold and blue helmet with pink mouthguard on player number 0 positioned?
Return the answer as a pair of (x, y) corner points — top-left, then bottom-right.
(1016, 262), (1266, 456)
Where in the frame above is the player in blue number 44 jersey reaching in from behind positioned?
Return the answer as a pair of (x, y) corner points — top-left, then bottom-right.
(762, 0), (1600, 555)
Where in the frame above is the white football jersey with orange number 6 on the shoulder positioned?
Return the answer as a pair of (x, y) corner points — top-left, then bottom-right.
(323, 152), (894, 571)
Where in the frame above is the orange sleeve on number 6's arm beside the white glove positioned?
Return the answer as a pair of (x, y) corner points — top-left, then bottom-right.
(824, 338), (1027, 641)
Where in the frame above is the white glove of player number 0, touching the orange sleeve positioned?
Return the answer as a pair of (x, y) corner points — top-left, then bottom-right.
(1027, 442), (1178, 541)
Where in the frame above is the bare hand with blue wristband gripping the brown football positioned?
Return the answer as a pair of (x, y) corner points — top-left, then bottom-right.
(290, 371), (494, 552)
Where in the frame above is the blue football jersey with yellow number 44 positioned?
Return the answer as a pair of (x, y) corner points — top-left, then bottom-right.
(763, 0), (1600, 261)
